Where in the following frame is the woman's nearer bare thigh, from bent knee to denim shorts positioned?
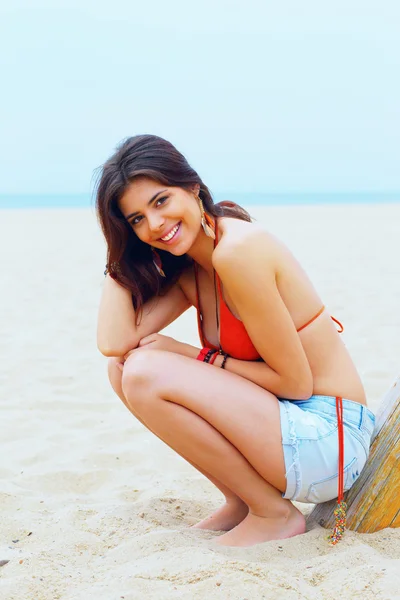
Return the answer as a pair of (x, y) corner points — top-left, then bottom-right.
(122, 348), (286, 491)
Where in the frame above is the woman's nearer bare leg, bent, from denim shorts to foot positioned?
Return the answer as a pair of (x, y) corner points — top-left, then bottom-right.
(122, 348), (305, 546)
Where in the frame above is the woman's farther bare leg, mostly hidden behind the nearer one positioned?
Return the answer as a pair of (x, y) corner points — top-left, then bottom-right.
(108, 358), (249, 531)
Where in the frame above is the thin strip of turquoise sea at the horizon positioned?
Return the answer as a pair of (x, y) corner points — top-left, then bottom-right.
(0, 191), (400, 209)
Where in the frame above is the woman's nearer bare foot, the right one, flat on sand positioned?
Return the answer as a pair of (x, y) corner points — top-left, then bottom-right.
(217, 505), (306, 547)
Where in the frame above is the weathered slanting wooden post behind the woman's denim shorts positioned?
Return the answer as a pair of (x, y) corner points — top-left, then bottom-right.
(307, 377), (400, 533)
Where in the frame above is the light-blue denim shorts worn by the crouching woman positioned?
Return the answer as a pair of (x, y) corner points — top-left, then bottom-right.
(279, 395), (375, 504)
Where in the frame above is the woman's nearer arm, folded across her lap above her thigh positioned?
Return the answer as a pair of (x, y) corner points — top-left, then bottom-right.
(214, 232), (313, 400)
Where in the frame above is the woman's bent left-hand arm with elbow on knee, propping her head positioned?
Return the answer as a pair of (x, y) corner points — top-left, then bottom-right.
(97, 275), (190, 356)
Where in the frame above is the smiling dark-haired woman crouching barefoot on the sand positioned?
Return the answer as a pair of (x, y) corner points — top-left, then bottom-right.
(97, 135), (374, 546)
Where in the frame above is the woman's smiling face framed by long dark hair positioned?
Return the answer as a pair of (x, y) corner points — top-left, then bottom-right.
(119, 177), (201, 256)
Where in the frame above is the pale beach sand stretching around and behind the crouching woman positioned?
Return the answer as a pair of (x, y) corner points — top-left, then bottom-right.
(0, 205), (400, 600)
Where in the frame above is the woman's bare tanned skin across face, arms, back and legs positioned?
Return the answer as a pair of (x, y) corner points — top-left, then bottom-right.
(99, 178), (365, 546)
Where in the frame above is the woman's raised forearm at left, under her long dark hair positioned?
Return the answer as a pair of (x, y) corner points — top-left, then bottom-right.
(97, 275), (139, 356)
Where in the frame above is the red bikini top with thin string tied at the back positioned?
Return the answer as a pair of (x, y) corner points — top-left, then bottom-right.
(194, 219), (343, 360)
